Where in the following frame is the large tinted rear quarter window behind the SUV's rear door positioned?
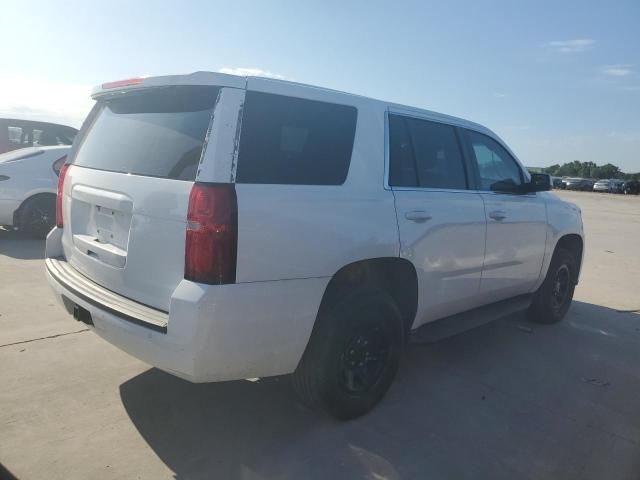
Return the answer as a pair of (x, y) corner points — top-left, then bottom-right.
(236, 92), (357, 185)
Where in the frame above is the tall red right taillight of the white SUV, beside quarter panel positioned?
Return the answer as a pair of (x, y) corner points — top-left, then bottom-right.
(184, 183), (238, 285)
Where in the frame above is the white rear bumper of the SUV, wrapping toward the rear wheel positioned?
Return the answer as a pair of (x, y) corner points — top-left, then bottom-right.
(47, 244), (329, 382)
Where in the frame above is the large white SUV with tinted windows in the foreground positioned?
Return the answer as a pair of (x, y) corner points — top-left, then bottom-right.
(46, 72), (583, 418)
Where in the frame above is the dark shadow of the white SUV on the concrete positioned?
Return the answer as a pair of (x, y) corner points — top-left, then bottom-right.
(120, 302), (640, 479)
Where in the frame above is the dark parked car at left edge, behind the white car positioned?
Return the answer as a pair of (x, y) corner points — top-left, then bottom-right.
(0, 118), (78, 154)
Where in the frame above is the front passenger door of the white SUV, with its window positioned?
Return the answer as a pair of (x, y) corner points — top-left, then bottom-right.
(462, 125), (547, 303)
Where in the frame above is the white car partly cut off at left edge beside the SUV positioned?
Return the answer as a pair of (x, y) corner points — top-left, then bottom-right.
(0, 146), (71, 238)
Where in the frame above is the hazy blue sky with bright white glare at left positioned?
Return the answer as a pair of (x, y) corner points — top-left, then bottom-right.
(0, 0), (640, 172)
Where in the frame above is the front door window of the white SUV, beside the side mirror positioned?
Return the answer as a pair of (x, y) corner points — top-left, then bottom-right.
(467, 130), (522, 191)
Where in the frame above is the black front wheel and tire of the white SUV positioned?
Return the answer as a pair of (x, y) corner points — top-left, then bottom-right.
(528, 248), (578, 324)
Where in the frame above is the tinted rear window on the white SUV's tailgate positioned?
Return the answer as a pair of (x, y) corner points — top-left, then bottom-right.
(73, 86), (219, 181)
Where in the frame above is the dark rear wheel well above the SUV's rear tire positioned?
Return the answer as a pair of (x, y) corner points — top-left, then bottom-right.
(320, 257), (418, 338)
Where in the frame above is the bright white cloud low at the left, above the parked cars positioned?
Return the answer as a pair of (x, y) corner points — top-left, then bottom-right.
(0, 76), (93, 127)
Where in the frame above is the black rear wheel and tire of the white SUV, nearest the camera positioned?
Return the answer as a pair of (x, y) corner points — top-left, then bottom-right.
(292, 289), (404, 420)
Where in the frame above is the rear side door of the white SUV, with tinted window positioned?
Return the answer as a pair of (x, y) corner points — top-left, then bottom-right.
(387, 112), (486, 327)
